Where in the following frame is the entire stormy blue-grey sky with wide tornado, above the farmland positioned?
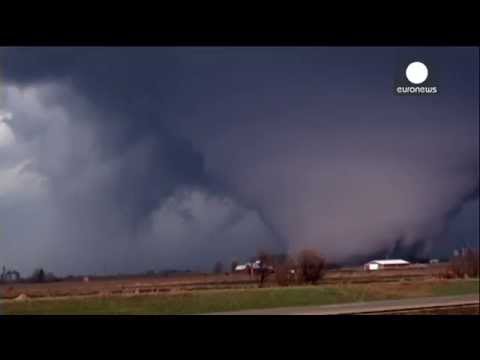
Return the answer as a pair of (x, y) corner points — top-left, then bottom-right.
(0, 47), (479, 275)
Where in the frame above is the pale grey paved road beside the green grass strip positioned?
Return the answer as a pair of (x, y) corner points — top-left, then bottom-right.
(210, 294), (480, 315)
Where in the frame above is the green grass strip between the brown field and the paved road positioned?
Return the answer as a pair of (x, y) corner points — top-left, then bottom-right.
(0, 279), (479, 315)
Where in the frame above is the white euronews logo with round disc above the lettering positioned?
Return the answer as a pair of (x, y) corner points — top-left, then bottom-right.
(394, 60), (438, 95)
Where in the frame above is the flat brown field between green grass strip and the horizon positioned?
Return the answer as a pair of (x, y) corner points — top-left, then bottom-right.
(0, 264), (452, 299)
